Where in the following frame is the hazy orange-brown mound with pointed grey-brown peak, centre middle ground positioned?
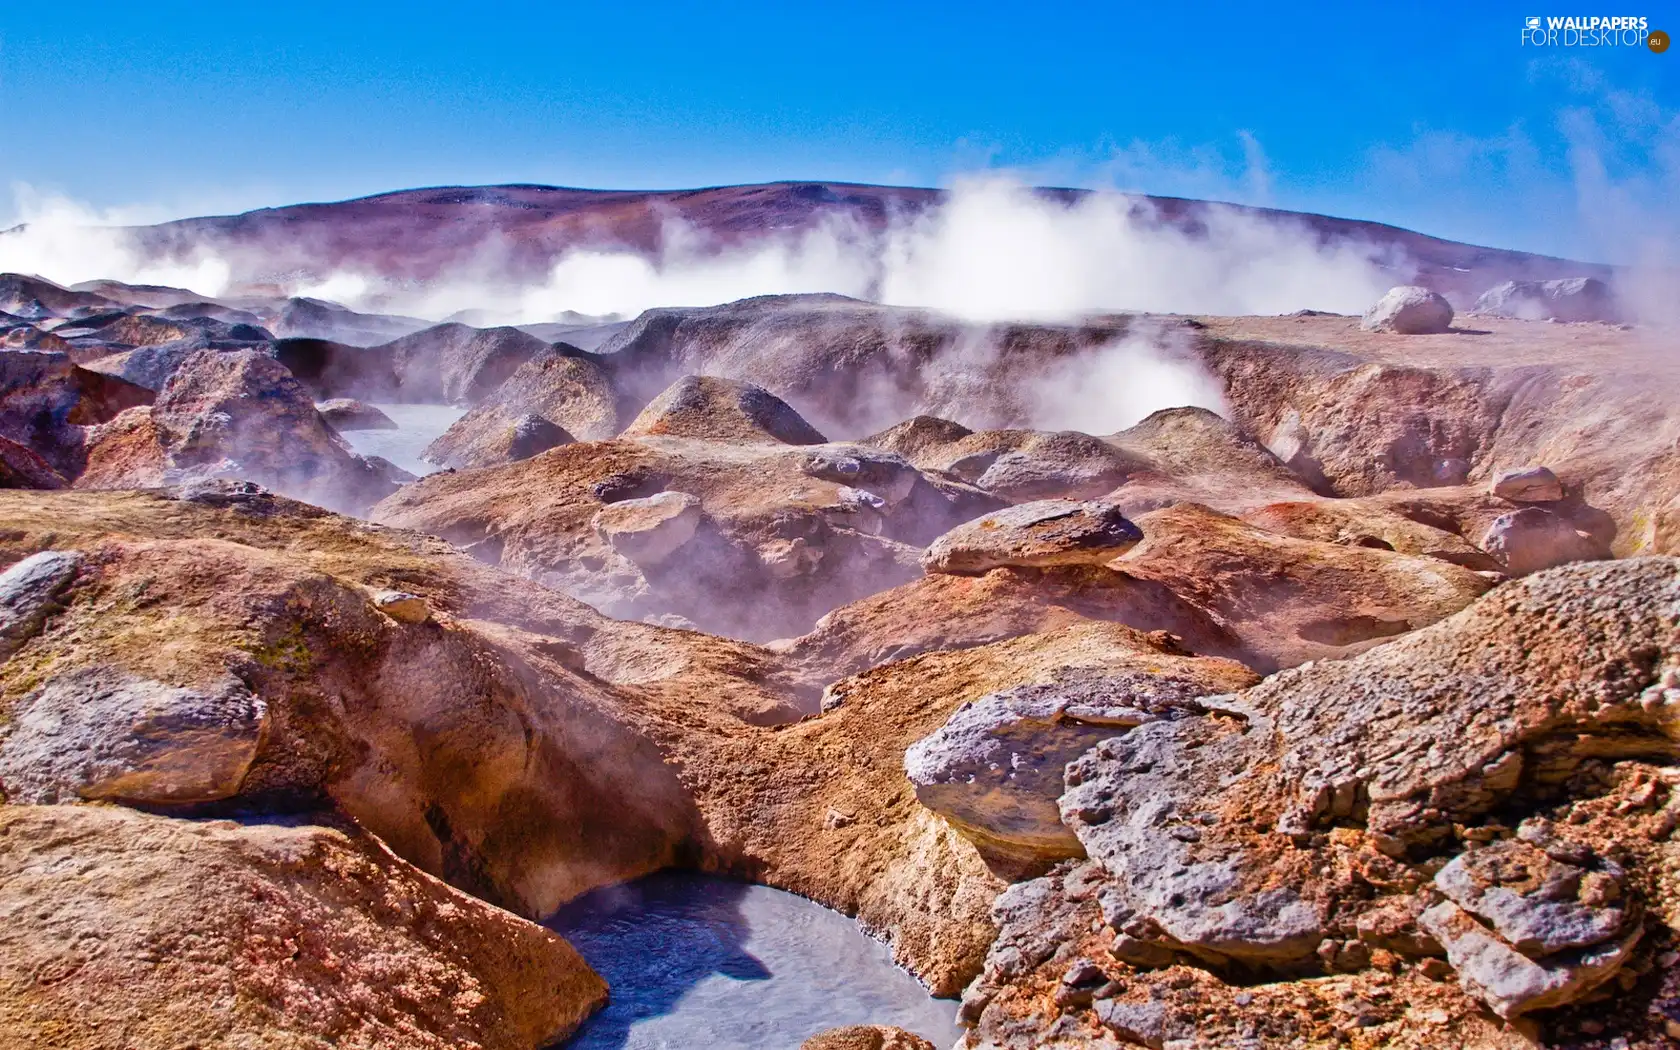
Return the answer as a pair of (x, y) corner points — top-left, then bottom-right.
(371, 393), (998, 640)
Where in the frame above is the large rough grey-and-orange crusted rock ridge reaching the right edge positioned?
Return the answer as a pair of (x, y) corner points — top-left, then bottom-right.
(1060, 559), (1680, 969)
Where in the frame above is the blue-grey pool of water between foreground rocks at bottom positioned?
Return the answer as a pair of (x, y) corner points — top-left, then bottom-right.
(549, 872), (961, 1050)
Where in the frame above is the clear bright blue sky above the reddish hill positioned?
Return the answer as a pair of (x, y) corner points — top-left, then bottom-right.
(0, 0), (1680, 257)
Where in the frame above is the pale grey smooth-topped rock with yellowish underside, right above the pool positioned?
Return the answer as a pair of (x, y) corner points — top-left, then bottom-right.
(904, 650), (1253, 879)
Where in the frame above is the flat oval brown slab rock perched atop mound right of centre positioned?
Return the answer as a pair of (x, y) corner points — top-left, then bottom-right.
(922, 499), (1144, 576)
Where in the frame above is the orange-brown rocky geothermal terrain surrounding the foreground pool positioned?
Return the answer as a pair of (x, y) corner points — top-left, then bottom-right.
(0, 198), (1680, 1050)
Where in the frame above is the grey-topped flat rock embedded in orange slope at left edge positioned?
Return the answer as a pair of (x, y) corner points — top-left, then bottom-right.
(0, 667), (267, 805)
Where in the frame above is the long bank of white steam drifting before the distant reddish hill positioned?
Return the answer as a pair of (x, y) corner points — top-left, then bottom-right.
(0, 178), (1393, 323)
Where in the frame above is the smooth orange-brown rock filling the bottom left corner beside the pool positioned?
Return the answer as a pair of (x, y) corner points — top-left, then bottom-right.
(0, 806), (606, 1050)
